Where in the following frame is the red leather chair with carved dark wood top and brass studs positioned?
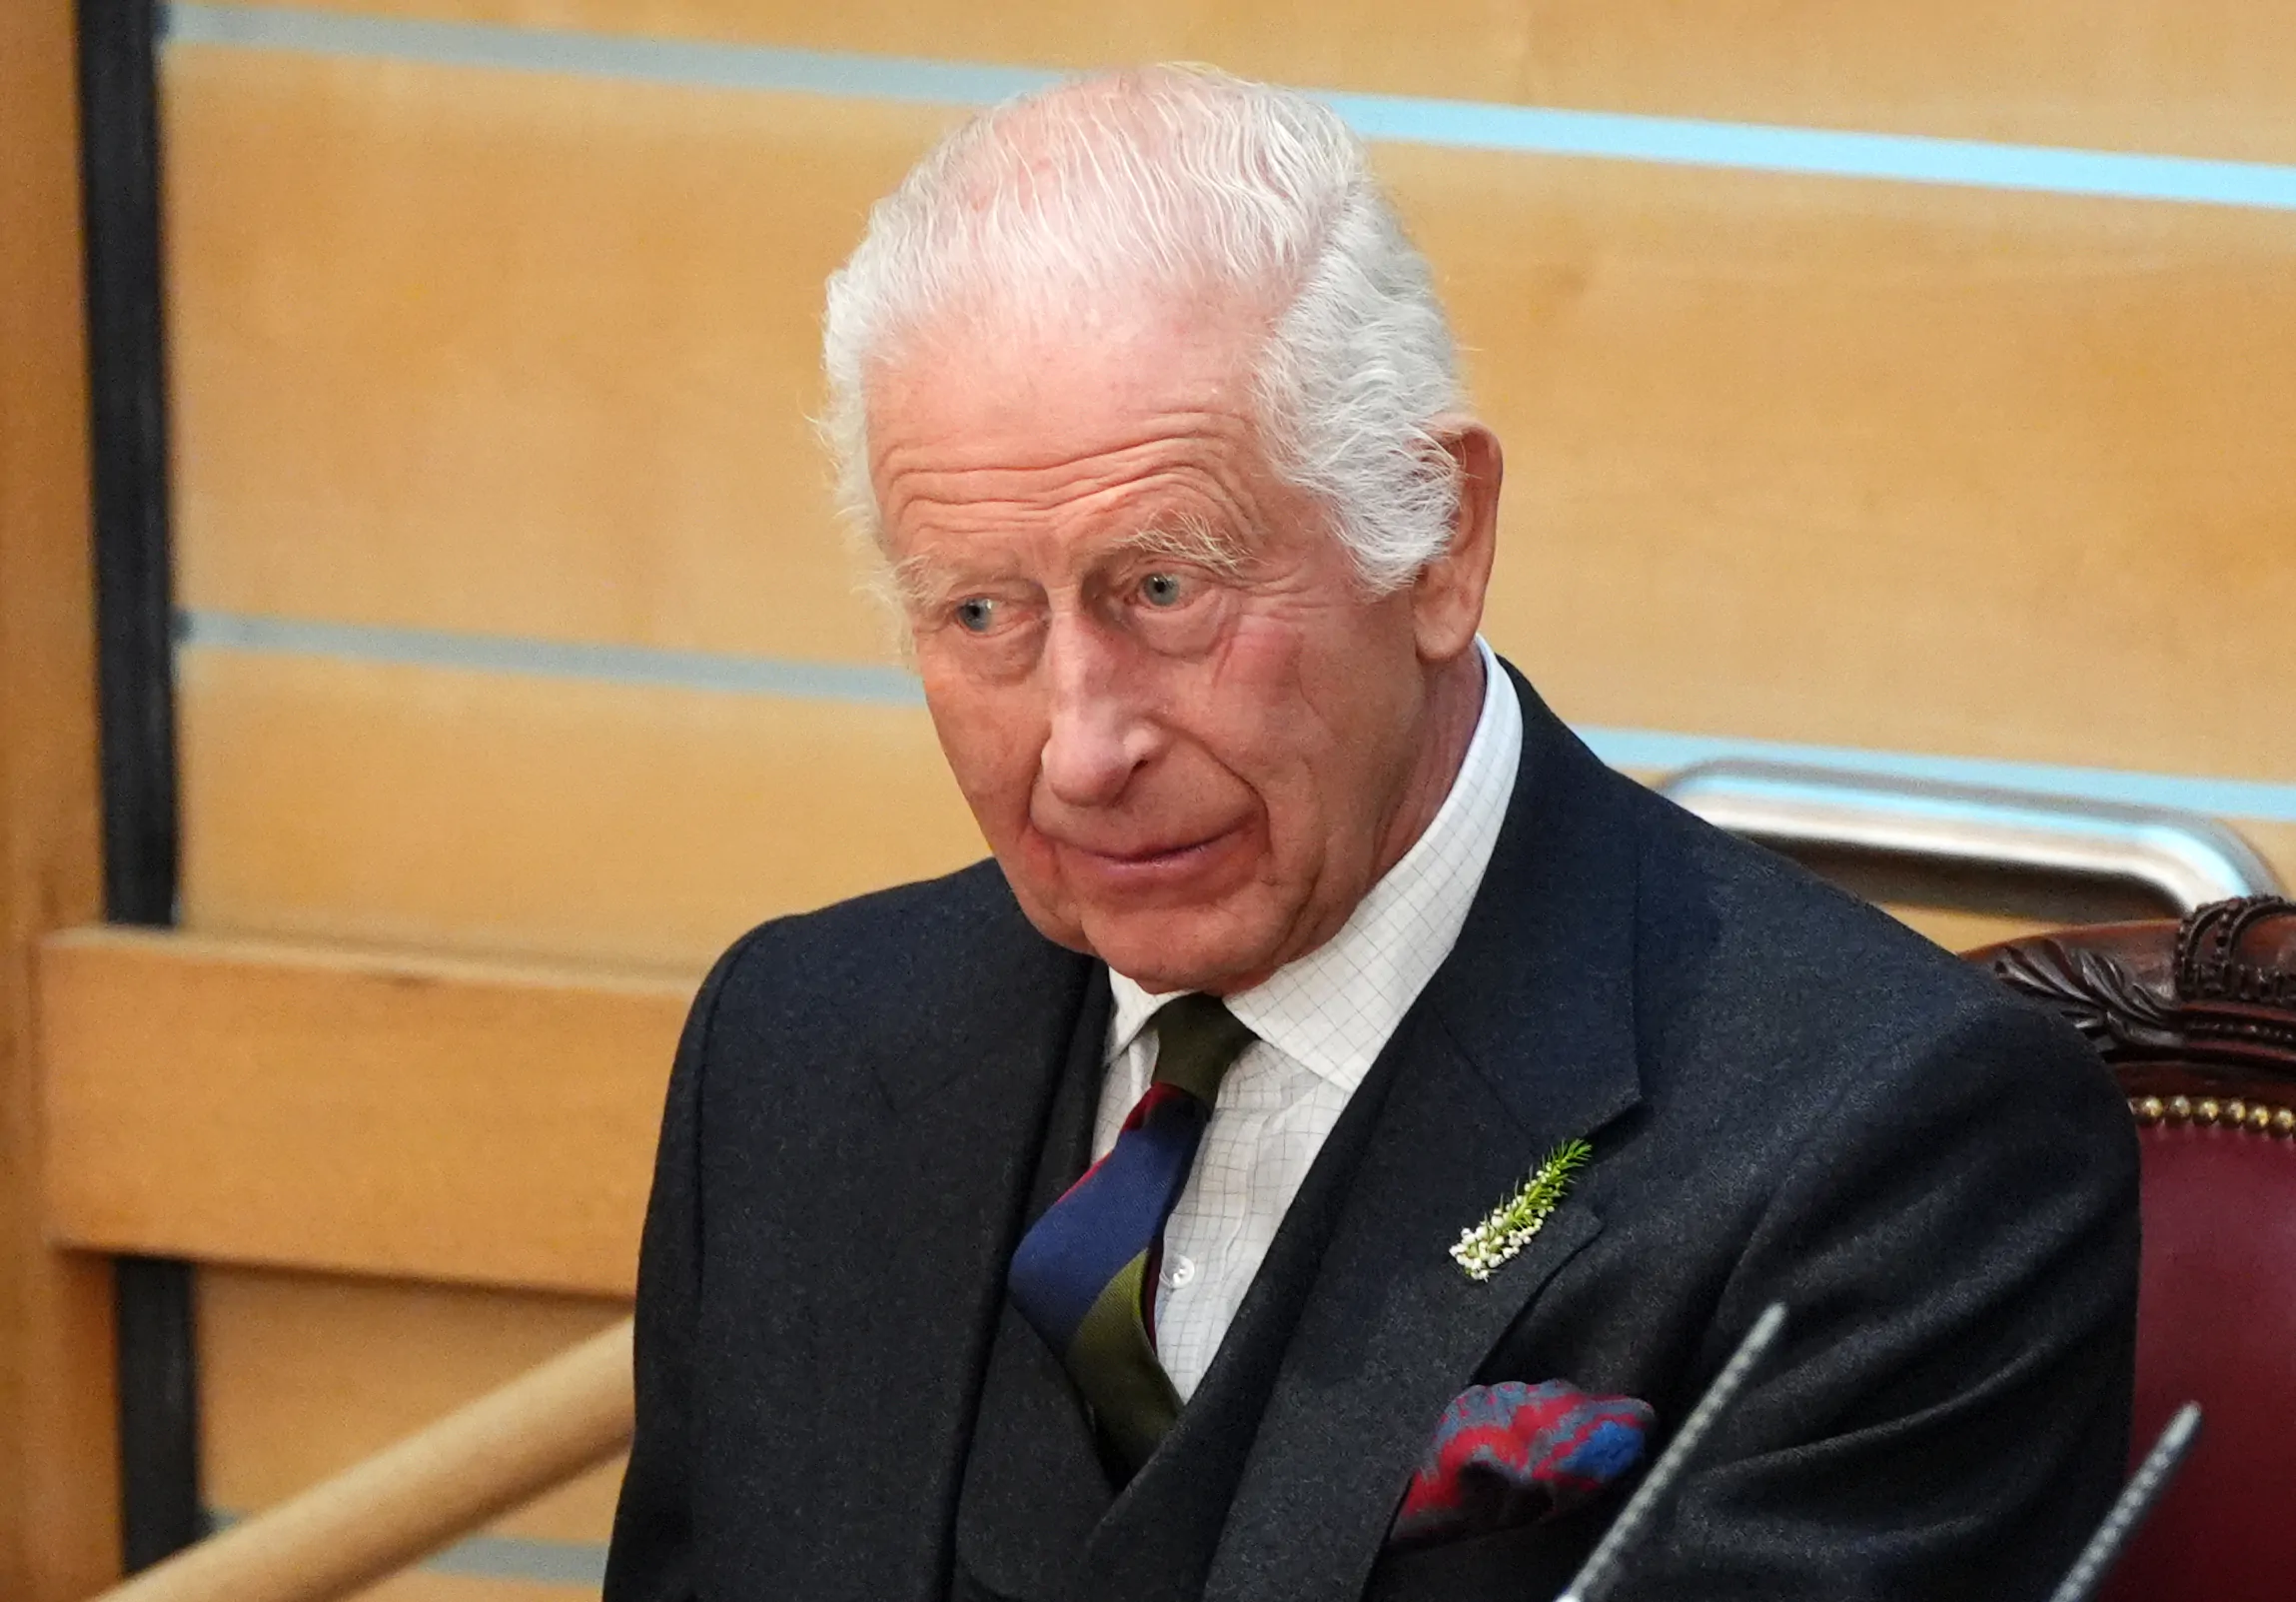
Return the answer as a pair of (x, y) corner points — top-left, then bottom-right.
(1970, 897), (2296, 1602)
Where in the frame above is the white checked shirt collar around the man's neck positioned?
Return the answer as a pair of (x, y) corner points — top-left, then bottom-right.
(1109, 636), (1523, 1092)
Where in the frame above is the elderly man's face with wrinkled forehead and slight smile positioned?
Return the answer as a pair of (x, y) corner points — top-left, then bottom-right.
(870, 296), (1472, 991)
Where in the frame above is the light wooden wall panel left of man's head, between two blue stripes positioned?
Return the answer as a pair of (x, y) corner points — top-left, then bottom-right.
(165, 48), (946, 659)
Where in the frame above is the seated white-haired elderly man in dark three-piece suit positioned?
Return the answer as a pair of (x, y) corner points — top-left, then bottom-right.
(606, 69), (2137, 1602)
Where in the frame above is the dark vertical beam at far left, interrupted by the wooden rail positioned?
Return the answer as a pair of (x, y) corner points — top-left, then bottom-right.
(78, 0), (205, 1570)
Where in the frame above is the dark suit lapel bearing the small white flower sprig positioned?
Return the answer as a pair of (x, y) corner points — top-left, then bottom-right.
(1203, 677), (1640, 1602)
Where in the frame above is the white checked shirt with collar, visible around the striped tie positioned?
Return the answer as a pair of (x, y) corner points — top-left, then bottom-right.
(1093, 641), (1523, 1400)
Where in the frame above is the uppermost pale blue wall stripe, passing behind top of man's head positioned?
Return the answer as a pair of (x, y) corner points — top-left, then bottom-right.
(168, 2), (2296, 211)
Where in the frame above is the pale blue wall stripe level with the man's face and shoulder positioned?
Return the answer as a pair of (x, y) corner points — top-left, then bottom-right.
(177, 611), (2296, 823)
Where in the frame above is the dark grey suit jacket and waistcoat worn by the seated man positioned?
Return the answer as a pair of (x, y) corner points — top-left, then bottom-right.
(606, 677), (2137, 1602)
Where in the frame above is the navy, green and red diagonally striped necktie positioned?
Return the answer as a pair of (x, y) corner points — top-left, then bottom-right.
(1008, 996), (1251, 1469)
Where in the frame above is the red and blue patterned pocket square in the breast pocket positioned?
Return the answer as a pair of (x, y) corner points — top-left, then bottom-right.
(1389, 1379), (1658, 1545)
